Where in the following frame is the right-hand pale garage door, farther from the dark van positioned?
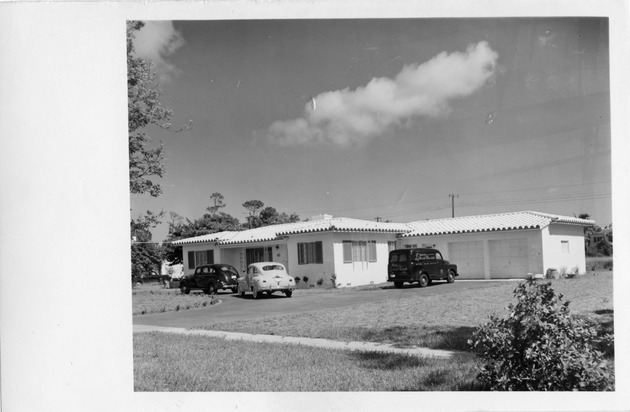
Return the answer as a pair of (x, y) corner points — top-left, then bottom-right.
(488, 239), (529, 279)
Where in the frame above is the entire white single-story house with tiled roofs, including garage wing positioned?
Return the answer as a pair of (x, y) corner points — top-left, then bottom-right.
(173, 212), (595, 287)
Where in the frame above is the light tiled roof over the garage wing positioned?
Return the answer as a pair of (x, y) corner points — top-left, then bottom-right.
(400, 212), (595, 237)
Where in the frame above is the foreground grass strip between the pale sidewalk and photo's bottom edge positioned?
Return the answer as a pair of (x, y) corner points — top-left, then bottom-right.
(134, 333), (483, 392)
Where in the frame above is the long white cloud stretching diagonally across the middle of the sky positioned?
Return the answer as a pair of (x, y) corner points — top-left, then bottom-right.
(267, 42), (498, 147)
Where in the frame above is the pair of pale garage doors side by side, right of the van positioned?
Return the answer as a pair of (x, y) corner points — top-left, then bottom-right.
(448, 238), (529, 279)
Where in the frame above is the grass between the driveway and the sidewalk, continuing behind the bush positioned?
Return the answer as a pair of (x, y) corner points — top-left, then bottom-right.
(194, 272), (613, 350)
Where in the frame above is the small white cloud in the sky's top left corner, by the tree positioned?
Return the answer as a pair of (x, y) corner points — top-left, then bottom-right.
(133, 21), (184, 77)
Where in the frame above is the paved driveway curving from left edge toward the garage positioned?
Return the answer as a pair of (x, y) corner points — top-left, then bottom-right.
(133, 281), (508, 328)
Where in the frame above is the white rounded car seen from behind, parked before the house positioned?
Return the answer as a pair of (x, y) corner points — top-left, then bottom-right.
(237, 262), (295, 299)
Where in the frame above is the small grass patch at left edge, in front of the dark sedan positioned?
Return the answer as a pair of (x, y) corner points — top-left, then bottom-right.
(132, 284), (219, 316)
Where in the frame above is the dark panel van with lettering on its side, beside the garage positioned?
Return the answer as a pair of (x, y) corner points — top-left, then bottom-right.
(387, 248), (459, 288)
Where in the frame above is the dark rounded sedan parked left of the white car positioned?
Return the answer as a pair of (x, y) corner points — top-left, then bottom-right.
(179, 264), (239, 295)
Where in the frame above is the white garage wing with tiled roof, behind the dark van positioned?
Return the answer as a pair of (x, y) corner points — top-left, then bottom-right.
(399, 212), (595, 279)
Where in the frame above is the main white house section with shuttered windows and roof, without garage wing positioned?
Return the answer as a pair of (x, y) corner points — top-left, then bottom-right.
(173, 215), (411, 287)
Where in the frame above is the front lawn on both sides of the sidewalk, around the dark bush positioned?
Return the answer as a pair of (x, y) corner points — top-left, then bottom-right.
(134, 272), (614, 392)
